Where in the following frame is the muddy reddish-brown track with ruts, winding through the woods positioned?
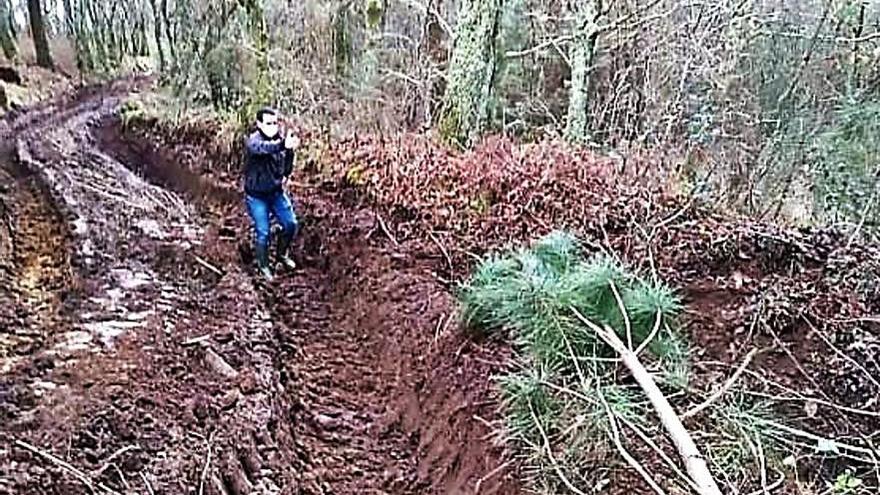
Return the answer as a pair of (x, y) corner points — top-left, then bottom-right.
(0, 81), (518, 495)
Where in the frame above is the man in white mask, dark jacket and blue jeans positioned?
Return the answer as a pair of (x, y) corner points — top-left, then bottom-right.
(244, 108), (299, 281)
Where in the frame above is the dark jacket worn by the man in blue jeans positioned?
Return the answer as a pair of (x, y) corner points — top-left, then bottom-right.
(244, 131), (293, 197)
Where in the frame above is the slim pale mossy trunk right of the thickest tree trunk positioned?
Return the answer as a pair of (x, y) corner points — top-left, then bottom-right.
(565, 0), (598, 143)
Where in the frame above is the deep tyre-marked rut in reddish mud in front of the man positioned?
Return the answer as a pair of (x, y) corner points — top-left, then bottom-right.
(275, 270), (427, 493)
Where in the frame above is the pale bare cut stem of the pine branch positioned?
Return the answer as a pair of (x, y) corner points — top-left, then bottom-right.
(571, 307), (721, 495)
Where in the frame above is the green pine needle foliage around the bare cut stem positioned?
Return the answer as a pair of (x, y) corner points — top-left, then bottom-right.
(458, 231), (792, 494)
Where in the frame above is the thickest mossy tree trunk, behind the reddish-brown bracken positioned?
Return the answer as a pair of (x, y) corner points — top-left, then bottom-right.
(438, 0), (503, 146)
